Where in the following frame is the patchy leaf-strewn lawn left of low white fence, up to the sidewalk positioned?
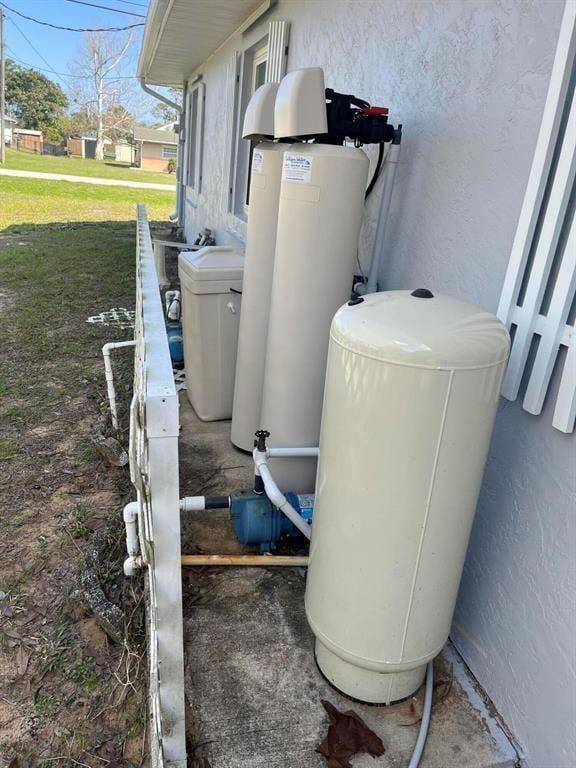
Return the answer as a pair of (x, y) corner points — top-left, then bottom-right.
(0, 172), (166, 768)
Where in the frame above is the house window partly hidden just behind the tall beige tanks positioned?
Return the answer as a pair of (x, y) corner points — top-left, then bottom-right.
(231, 39), (268, 218)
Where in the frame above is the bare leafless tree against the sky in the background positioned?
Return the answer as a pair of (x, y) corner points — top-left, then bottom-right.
(70, 32), (135, 160)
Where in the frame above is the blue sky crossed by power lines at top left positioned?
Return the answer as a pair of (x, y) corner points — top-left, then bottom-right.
(0, 0), (148, 97)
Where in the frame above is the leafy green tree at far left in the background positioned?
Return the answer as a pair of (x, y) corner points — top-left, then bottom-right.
(6, 59), (68, 138)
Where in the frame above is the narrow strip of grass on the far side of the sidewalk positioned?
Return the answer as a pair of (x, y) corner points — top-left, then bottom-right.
(0, 149), (176, 186)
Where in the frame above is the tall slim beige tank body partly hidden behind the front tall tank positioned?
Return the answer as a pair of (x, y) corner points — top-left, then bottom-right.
(230, 142), (287, 451)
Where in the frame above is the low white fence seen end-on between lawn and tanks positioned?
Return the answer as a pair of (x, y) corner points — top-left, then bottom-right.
(129, 205), (186, 768)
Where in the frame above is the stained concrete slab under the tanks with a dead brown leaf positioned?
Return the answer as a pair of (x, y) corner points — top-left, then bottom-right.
(180, 394), (516, 768)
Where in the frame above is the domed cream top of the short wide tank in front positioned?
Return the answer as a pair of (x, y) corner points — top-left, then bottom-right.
(330, 288), (510, 370)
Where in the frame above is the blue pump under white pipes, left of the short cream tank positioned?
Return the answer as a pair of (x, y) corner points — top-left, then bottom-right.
(230, 493), (314, 552)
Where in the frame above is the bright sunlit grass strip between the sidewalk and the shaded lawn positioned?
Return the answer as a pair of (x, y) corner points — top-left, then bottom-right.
(0, 177), (176, 231)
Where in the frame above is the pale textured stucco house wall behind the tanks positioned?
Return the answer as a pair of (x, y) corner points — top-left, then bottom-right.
(186, 0), (576, 768)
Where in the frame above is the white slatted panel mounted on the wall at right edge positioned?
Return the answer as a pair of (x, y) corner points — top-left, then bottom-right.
(498, 0), (576, 432)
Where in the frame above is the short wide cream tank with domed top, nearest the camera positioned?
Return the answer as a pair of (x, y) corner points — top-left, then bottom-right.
(306, 289), (509, 704)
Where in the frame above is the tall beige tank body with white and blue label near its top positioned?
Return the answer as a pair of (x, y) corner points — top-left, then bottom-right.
(260, 144), (369, 493)
